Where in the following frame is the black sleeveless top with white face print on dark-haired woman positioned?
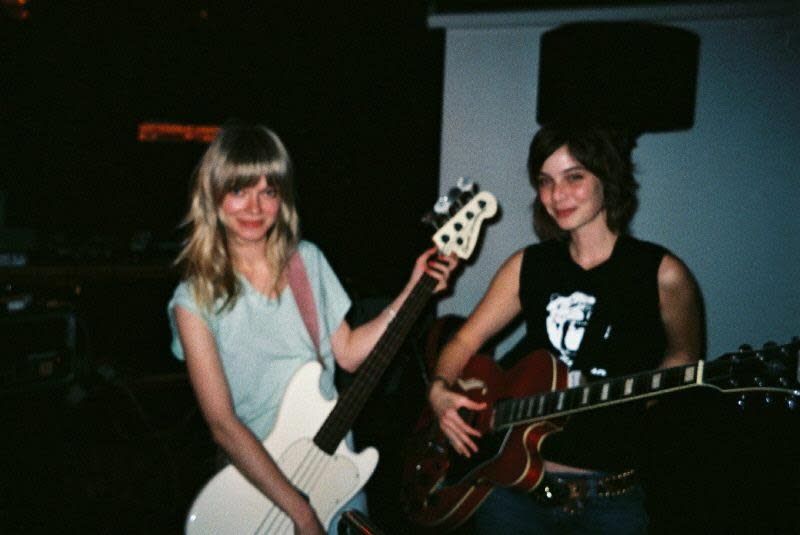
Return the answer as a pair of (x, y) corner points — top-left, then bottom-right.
(519, 235), (667, 471)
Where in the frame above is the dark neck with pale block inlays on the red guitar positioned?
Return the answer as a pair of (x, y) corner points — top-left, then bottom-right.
(494, 361), (716, 429)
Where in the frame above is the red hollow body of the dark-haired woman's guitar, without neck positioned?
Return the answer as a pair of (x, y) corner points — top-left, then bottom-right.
(403, 350), (567, 529)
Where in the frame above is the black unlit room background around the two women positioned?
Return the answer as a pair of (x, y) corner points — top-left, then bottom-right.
(0, 0), (800, 533)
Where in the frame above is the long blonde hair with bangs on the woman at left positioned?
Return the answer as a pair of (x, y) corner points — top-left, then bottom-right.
(175, 124), (300, 313)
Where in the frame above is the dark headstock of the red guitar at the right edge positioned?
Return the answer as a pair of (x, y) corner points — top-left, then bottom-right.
(703, 337), (800, 409)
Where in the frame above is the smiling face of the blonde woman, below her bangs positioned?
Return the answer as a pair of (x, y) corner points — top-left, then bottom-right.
(220, 176), (281, 244)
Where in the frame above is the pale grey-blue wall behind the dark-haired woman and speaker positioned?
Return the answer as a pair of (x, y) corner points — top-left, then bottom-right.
(429, 2), (800, 357)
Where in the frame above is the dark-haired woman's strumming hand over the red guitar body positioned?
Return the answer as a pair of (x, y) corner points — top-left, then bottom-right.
(428, 381), (486, 457)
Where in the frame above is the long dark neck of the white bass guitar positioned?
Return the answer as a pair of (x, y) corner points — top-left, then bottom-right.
(314, 274), (436, 455)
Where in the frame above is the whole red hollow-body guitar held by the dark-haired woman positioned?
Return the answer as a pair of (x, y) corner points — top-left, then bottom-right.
(402, 339), (800, 530)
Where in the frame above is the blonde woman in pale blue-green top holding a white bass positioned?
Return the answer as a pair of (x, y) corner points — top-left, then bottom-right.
(168, 125), (456, 533)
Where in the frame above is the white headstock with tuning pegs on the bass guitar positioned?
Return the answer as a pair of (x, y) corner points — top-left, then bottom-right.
(422, 177), (497, 260)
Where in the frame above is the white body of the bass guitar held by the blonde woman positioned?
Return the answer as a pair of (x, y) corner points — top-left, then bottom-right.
(185, 362), (378, 535)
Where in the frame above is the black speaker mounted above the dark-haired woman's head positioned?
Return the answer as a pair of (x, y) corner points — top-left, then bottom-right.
(536, 22), (700, 135)
